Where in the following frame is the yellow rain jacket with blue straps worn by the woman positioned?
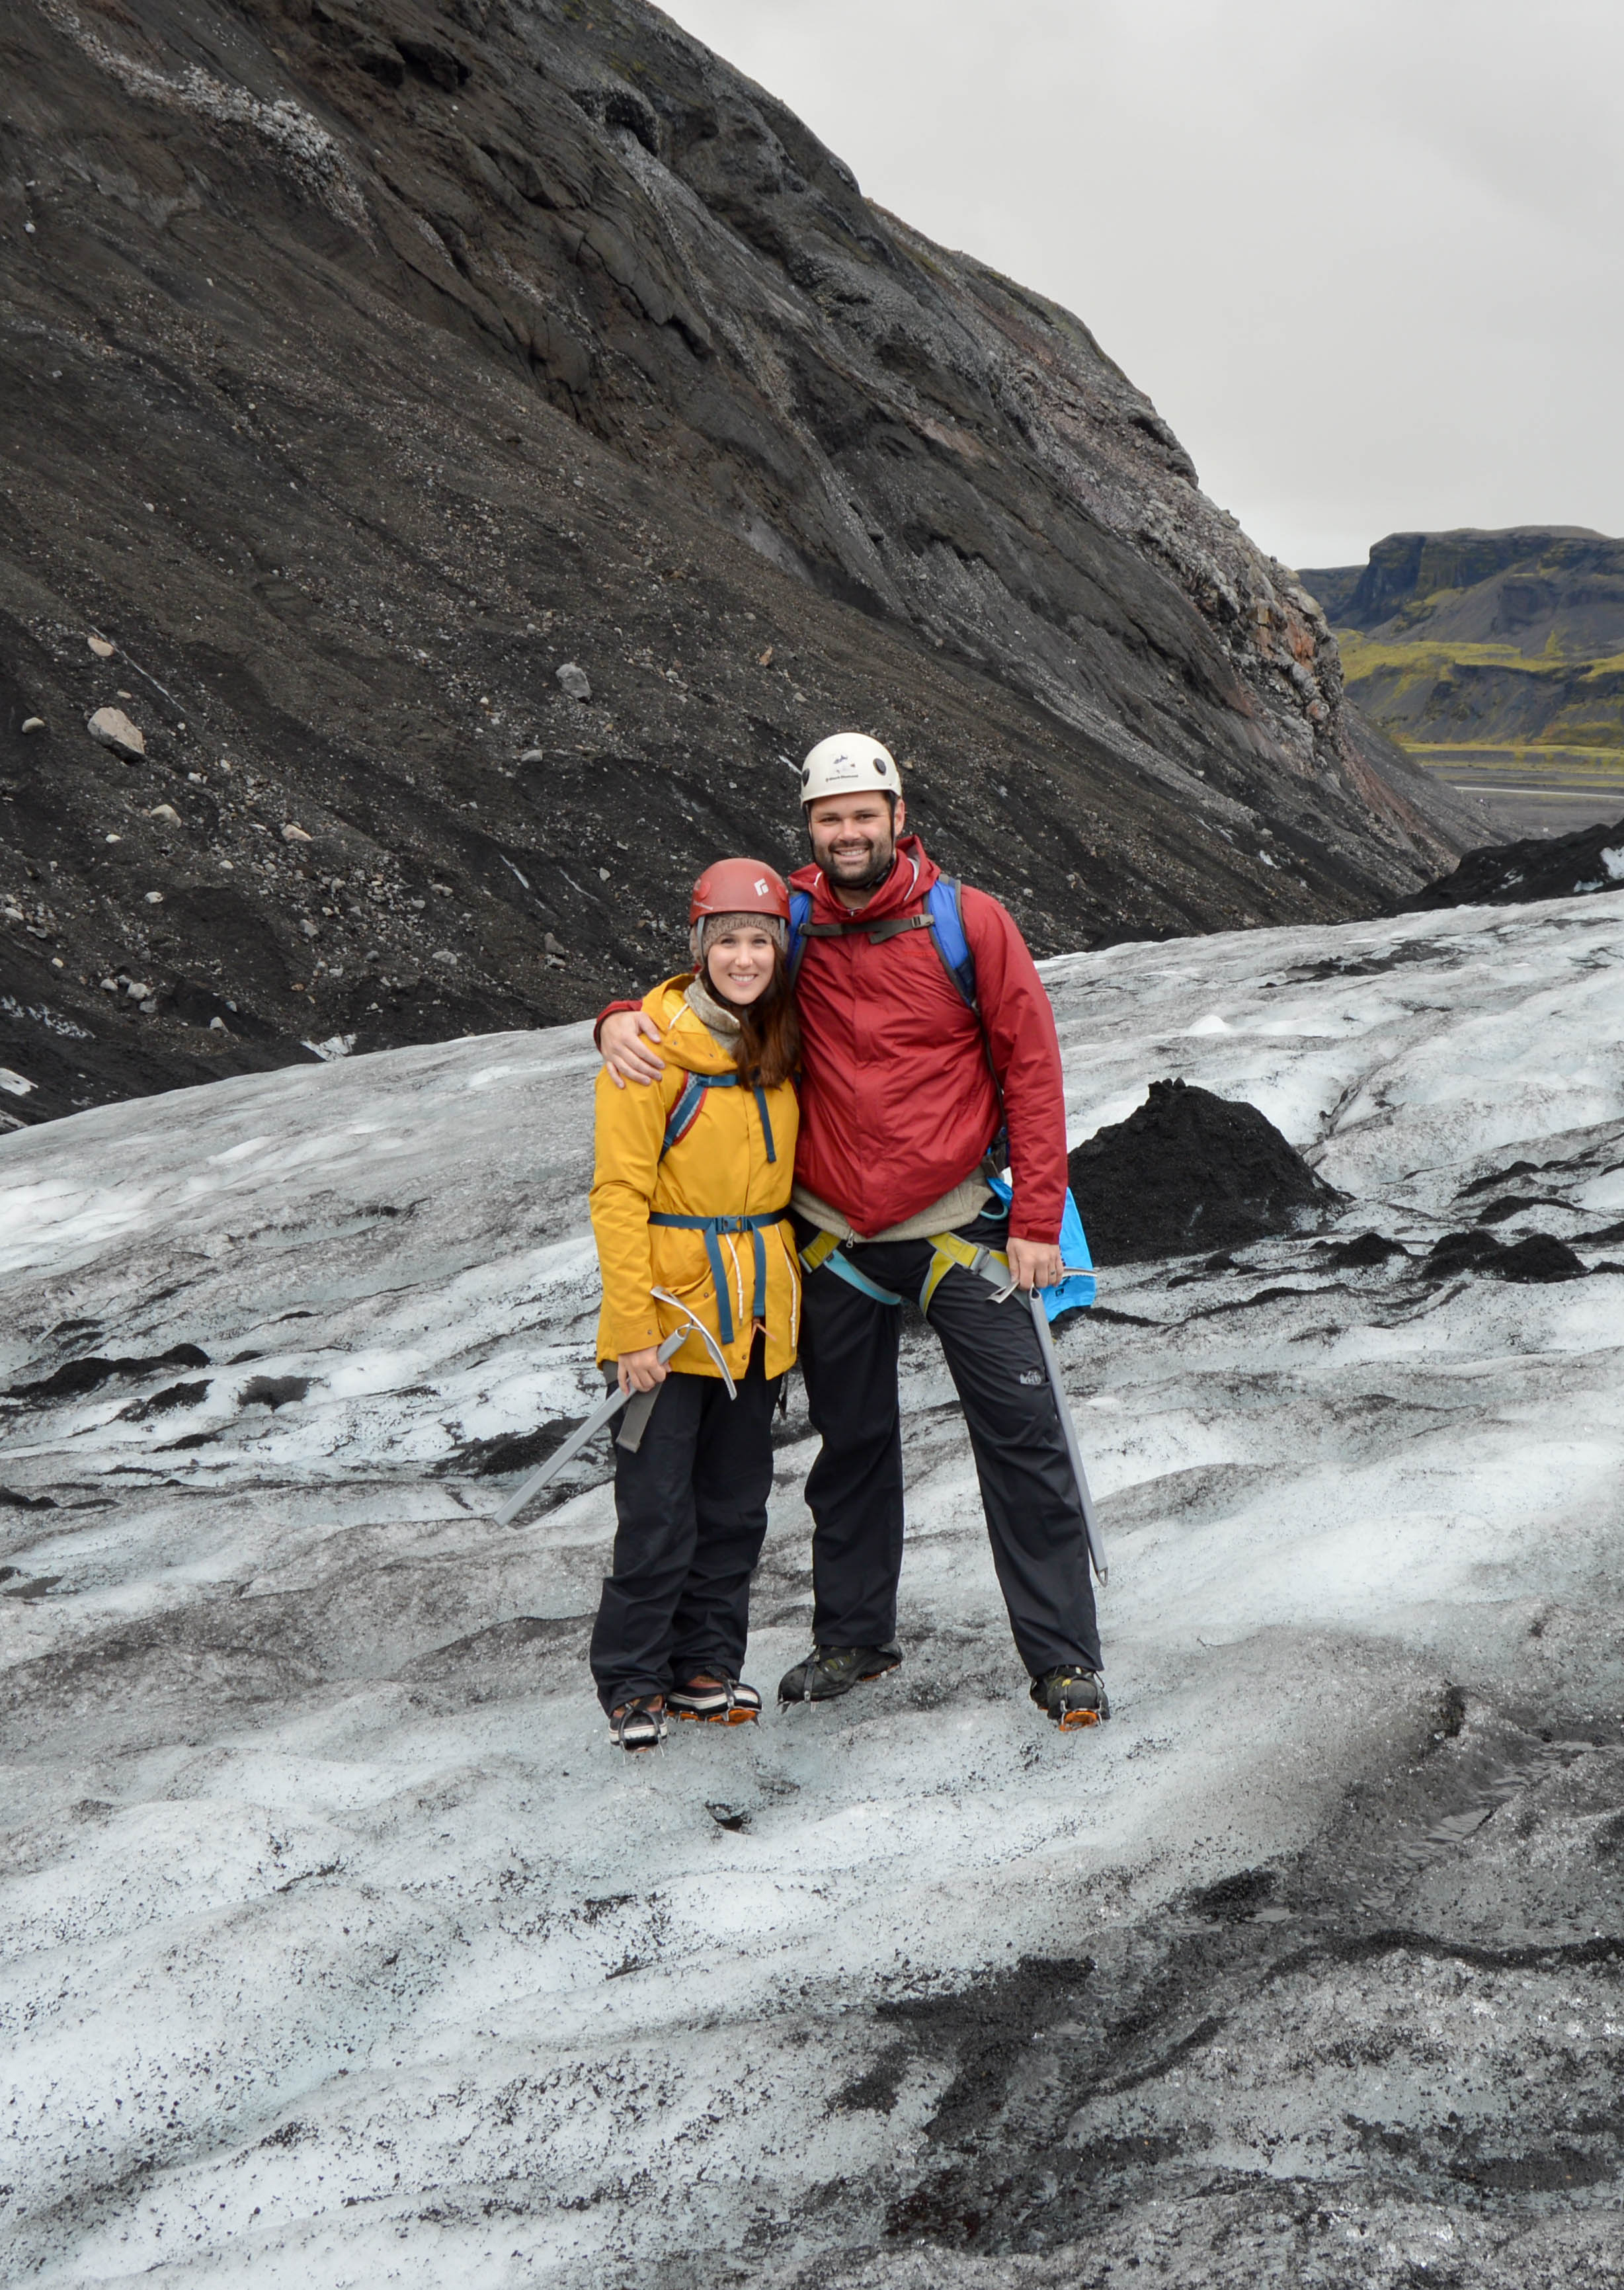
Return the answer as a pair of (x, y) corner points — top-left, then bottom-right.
(591, 975), (801, 1376)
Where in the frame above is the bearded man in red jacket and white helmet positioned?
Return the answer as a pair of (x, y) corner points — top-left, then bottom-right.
(600, 733), (1111, 1729)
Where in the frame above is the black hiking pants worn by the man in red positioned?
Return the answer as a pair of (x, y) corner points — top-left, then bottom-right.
(795, 1216), (1102, 1678)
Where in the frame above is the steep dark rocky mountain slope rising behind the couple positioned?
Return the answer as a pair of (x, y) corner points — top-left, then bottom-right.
(0, 0), (1482, 1120)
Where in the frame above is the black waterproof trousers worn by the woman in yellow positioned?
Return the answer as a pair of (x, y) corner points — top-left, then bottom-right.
(591, 1337), (784, 1713)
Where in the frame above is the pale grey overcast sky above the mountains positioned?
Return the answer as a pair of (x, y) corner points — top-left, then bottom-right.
(669, 0), (1624, 565)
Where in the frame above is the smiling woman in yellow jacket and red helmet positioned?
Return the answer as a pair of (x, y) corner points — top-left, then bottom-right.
(591, 859), (801, 1750)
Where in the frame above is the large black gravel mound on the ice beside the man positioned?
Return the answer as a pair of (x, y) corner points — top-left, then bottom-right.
(1067, 1081), (1342, 1264)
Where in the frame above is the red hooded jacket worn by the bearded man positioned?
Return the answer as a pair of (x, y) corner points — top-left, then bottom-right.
(602, 836), (1065, 1241)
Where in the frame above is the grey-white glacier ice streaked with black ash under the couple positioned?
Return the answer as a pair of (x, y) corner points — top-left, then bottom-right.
(0, 895), (1624, 2285)
